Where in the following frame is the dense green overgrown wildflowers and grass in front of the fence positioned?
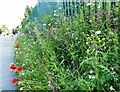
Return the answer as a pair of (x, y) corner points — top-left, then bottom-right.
(15, 1), (120, 92)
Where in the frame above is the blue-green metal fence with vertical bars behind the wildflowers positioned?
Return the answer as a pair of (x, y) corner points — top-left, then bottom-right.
(31, 0), (120, 22)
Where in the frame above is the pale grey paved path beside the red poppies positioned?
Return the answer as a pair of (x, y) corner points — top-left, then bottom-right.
(0, 35), (16, 92)
